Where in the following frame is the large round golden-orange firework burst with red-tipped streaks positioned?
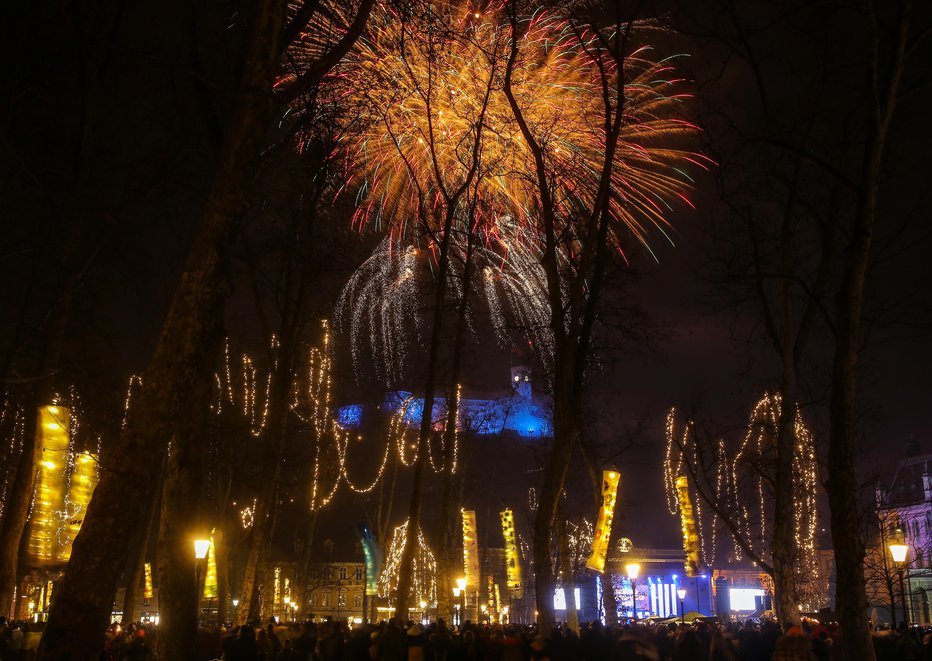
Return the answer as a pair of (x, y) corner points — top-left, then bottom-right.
(338, 3), (709, 254)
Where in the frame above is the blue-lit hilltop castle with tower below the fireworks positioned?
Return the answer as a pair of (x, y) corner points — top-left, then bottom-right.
(337, 366), (552, 438)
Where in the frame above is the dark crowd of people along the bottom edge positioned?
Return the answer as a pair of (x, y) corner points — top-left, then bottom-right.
(0, 618), (932, 661)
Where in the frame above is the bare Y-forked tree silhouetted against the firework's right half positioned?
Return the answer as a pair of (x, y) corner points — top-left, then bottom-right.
(504, 2), (700, 632)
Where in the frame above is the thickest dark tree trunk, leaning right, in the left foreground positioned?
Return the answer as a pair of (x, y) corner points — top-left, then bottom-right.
(38, 0), (283, 661)
